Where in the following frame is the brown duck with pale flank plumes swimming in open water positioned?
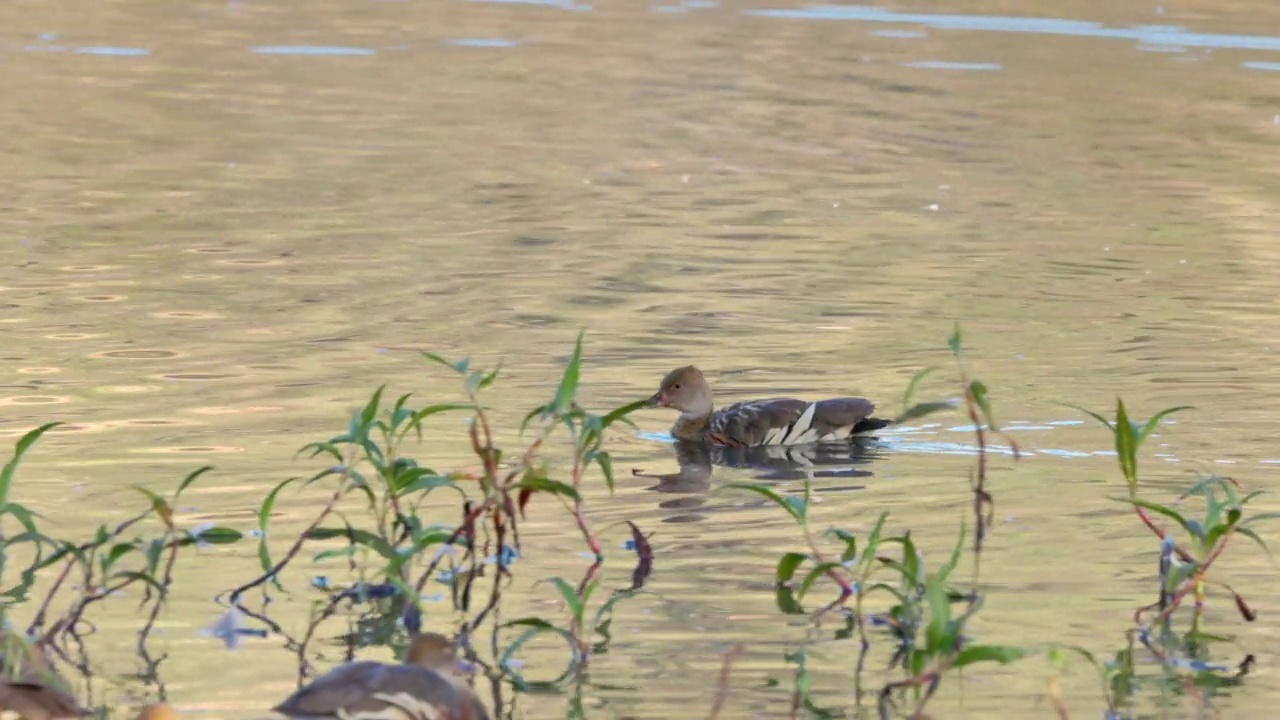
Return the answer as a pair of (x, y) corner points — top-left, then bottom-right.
(649, 365), (893, 447)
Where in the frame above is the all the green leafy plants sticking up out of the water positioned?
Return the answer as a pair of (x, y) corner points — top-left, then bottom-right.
(0, 327), (1274, 717)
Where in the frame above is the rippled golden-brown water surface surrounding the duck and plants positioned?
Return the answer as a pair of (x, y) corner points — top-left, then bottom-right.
(0, 0), (1280, 717)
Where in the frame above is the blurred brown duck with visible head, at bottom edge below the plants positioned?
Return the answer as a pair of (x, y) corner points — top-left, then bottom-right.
(271, 633), (489, 720)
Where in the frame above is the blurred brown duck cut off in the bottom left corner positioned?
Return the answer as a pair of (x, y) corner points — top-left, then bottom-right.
(0, 630), (93, 720)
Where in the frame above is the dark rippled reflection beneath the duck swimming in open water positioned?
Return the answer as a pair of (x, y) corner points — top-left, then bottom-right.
(631, 438), (882, 523)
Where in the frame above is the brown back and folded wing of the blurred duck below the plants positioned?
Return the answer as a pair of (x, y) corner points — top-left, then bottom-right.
(273, 661), (465, 720)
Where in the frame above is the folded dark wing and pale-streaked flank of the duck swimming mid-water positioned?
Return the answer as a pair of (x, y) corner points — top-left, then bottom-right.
(708, 397), (888, 447)
